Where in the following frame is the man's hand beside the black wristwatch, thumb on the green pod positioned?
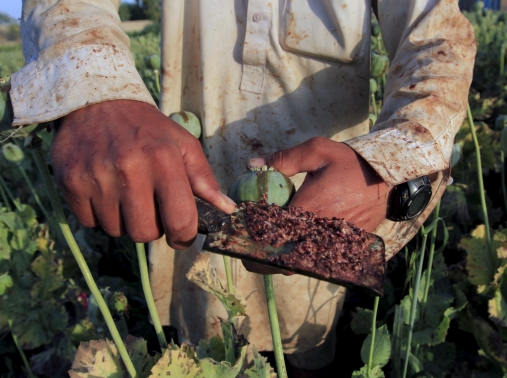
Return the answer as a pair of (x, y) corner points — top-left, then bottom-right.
(243, 137), (389, 274)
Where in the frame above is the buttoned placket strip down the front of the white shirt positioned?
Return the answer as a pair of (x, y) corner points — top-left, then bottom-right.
(240, 0), (272, 93)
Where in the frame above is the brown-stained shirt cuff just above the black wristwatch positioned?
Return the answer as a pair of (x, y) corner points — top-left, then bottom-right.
(343, 122), (449, 186)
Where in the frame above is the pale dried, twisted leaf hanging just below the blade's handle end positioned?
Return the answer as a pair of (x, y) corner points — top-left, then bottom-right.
(187, 253), (246, 320)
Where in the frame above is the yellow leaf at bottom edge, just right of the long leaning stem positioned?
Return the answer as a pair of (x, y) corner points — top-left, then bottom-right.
(149, 348), (200, 378)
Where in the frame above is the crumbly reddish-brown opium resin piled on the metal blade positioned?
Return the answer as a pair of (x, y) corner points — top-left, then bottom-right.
(240, 201), (376, 281)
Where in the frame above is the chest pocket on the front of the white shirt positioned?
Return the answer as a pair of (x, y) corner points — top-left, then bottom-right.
(279, 0), (370, 63)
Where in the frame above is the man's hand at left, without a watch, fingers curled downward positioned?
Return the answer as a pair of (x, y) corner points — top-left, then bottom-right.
(51, 100), (235, 249)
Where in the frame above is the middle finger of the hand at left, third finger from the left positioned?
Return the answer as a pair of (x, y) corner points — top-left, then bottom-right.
(121, 185), (164, 243)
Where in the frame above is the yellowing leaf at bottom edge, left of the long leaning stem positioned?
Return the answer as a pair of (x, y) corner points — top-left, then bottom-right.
(69, 340), (124, 378)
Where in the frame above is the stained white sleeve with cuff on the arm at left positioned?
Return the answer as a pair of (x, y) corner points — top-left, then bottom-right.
(10, 0), (156, 126)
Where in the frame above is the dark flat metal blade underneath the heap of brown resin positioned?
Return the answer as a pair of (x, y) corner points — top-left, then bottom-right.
(203, 210), (386, 295)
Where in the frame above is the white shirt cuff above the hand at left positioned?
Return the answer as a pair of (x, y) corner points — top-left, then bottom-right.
(10, 45), (157, 126)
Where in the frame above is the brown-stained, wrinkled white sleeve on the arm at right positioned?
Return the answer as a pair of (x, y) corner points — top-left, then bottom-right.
(345, 0), (476, 186)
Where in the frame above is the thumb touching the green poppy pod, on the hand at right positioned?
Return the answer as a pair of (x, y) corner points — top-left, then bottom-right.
(249, 137), (330, 176)
